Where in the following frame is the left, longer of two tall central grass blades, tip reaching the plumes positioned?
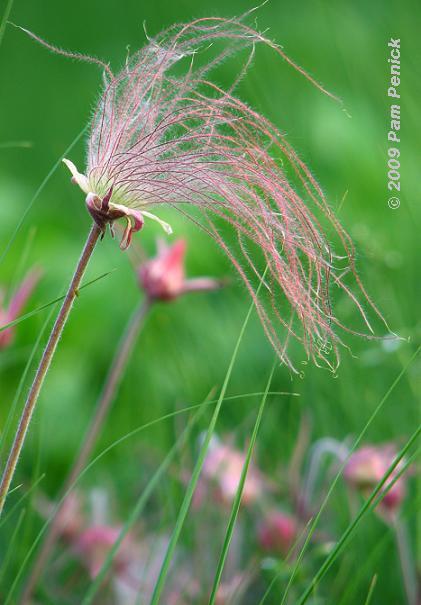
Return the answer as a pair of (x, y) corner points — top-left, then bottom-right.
(151, 286), (260, 605)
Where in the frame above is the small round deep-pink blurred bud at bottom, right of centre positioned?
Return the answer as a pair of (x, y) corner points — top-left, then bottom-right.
(258, 510), (297, 556)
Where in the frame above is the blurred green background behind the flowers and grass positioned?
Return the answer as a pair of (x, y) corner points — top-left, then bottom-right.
(0, 0), (421, 605)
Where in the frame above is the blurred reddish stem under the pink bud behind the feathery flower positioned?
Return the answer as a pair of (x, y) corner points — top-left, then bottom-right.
(21, 299), (151, 605)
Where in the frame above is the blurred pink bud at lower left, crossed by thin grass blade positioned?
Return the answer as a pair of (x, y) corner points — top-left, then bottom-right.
(75, 525), (131, 578)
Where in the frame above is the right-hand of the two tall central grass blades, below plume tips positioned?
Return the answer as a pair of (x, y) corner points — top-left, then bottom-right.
(209, 361), (277, 605)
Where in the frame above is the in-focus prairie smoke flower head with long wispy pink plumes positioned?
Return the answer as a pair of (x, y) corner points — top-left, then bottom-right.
(56, 18), (381, 369)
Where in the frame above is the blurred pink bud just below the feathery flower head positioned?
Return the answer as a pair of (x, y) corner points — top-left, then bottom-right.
(138, 240), (221, 301)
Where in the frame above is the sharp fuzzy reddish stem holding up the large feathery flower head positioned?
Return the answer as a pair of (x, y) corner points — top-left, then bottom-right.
(0, 224), (101, 515)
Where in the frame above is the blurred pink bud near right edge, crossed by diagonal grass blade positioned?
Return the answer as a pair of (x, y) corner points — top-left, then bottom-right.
(344, 445), (405, 513)
